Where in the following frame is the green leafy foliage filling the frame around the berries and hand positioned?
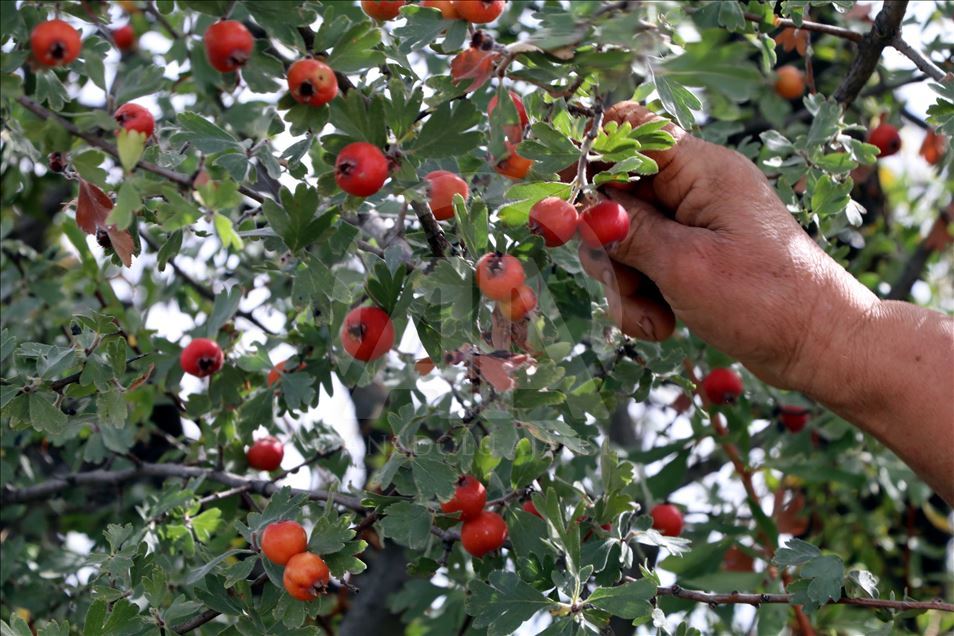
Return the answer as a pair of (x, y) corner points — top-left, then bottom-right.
(0, 0), (954, 636)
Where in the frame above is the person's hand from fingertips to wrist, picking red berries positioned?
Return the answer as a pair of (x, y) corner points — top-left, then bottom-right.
(580, 102), (877, 390)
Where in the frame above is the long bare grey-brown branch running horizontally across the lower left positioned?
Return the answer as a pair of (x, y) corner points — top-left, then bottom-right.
(0, 462), (364, 512)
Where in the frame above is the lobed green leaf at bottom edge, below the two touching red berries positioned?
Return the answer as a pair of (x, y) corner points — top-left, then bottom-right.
(466, 570), (555, 636)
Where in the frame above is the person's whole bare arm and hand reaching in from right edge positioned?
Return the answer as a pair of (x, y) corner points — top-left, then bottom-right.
(580, 102), (954, 504)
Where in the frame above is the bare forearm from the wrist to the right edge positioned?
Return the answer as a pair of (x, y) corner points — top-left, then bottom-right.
(806, 290), (954, 503)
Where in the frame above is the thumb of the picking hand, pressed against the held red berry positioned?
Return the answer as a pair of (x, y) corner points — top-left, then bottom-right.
(608, 190), (697, 290)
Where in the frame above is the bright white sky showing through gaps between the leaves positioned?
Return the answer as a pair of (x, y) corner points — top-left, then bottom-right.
(20, 2), (954, 634)
